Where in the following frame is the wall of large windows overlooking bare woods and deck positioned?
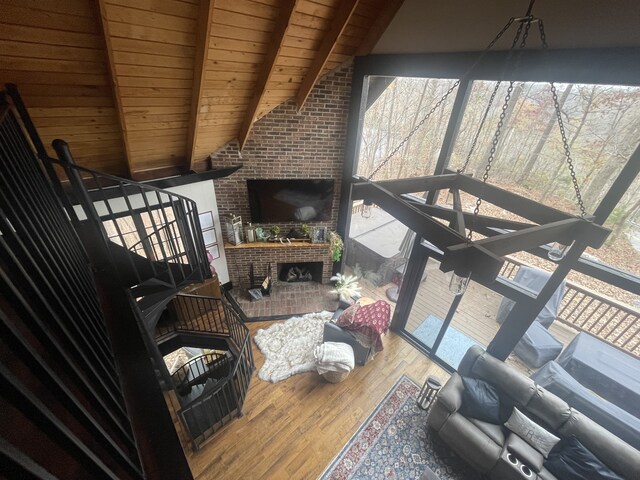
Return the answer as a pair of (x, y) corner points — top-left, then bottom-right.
(346, 51), (640, 368)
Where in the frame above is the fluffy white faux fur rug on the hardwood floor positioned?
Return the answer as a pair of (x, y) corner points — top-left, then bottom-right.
(253, 312), (333, 383)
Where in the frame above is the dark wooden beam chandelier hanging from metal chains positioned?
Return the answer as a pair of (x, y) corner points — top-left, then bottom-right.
(351, 0), (611, 284)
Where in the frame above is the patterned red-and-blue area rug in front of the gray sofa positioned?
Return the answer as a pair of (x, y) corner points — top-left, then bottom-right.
(320, 375), (480, 480)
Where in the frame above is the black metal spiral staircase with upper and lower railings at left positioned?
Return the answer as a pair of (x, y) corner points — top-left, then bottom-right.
(9, 83), (254, 454)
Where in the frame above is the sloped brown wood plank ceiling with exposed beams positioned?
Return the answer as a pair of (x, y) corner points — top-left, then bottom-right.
(0, 0), (402, 179)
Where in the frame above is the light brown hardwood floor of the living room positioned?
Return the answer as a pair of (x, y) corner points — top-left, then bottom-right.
(176, 322), (449, 480)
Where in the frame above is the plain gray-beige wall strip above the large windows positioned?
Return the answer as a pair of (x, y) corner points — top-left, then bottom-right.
(373, 0), (640, 53)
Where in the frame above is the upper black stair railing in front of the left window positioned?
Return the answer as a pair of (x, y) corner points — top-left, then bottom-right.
(50, 140), (211, 294)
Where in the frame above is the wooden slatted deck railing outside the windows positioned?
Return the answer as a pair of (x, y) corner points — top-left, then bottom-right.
(500, 258), (640, 357)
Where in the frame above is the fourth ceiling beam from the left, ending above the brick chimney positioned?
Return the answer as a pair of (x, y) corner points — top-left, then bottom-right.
(296, 0), (358, 111)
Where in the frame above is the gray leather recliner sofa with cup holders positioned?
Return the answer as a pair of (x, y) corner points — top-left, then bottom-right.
(427, 346), (640, 480)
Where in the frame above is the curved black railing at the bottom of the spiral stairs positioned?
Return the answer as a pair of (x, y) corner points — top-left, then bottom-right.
(156, 294), (254, 449)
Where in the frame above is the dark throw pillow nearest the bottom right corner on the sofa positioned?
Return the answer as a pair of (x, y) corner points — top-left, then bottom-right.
(544, 436), (622, 480)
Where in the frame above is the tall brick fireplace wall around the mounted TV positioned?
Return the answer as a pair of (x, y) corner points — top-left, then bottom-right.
(210, 65), (352, 286)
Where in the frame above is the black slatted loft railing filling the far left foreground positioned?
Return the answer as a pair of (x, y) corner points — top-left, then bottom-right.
(0, 93), (144, 479)
